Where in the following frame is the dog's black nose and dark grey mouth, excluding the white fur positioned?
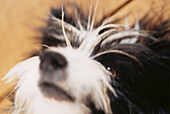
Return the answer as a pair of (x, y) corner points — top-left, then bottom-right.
(38, 51), (74, 101)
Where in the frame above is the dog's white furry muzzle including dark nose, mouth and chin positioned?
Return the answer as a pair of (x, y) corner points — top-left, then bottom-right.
(10, 47), (114, 114)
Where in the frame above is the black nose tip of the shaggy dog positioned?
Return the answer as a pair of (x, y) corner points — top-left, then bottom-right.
(40, 51), (67, 71)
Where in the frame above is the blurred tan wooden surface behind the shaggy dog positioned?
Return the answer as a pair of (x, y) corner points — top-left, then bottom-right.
(0, 0), (170, 112)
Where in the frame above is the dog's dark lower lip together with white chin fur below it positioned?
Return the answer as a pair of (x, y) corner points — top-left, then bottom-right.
(36, 77), (90, 114)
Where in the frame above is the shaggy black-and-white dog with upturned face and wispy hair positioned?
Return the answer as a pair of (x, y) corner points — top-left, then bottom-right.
(1, 1), (170, 114)
